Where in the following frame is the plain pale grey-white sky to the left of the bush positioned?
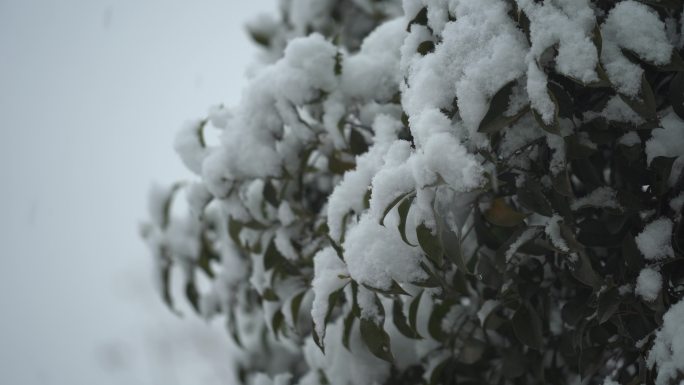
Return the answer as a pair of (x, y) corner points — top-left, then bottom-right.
(0, 0), (275, 385)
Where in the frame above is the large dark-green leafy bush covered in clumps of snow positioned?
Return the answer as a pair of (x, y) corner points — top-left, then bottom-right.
(143, 0), (684, 385)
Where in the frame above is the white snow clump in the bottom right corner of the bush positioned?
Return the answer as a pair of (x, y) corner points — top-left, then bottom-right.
(646, 300), (684, 385)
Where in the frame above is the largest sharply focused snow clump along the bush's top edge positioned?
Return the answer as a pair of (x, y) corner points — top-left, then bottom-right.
(402, 0), (527, 144)
